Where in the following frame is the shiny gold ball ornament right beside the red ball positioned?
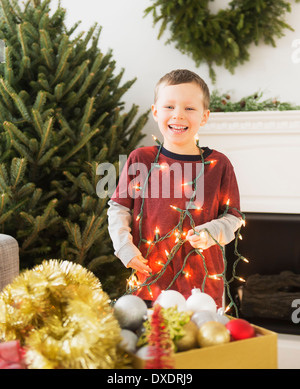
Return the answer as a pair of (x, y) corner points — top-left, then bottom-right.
(197, 321), (230, 347)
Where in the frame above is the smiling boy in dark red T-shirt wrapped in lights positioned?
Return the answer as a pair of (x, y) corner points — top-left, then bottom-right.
(108, 70), (241, 307)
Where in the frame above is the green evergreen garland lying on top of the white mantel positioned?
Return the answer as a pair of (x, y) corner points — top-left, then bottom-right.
(210, 90), (300, 112)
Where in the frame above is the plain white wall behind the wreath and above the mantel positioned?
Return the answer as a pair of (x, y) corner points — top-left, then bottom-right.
(58, 0), (300, 145)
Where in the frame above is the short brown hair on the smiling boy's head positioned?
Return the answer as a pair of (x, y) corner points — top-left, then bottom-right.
(154, 69), (210, 109)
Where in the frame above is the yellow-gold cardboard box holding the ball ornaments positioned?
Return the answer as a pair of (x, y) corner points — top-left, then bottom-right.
(133, 325), (277, 369)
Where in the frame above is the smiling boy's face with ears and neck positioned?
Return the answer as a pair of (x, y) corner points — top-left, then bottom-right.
(152, 82), (209, 154)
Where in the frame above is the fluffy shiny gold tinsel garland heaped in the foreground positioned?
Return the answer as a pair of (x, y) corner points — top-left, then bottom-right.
(0, 260), (126, 369)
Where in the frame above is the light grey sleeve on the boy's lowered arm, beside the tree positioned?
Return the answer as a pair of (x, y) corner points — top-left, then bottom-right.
(107, 200), (142, 267)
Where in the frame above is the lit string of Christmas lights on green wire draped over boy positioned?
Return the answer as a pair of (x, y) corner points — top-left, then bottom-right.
(125, 136), (245, 316)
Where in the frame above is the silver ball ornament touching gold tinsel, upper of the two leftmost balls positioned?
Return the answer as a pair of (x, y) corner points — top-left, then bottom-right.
(114, 295), (147, 331)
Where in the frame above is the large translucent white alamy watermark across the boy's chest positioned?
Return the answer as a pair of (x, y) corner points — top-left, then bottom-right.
(96, 155), (204, 208)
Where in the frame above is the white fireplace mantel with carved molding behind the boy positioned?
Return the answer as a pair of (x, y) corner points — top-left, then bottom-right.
(199, 111), (300, 213)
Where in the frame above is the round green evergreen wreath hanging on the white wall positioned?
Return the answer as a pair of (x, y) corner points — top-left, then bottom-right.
(145, 0), (300, 82)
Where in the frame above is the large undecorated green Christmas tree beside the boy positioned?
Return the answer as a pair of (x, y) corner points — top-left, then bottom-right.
(0, 0), (148, 297)
